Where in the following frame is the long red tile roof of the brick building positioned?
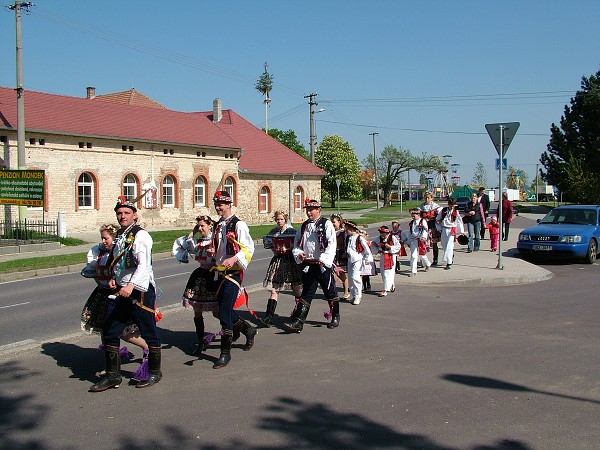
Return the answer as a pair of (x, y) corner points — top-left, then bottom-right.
(0, 87), (326, 176)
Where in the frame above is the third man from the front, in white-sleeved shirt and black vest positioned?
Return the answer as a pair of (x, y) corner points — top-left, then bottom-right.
(284, 199), (340, 333)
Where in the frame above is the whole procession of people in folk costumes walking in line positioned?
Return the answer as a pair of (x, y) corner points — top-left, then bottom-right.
(81, 185), (512, 392)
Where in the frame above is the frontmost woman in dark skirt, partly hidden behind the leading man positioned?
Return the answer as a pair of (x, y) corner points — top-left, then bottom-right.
(81, 224), (148, 379)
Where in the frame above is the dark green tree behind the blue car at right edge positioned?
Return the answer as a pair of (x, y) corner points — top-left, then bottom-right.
(540, 71), (600, 204)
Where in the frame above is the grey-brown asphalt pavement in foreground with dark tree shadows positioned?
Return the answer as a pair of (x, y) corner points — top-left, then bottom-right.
(0, 258), (600, 450)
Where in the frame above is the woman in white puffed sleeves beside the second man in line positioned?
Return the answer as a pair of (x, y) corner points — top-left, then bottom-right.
(182, 216), (219, 356)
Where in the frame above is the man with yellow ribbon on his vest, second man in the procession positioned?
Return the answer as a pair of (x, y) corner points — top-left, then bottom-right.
(212, 191), (256, 369)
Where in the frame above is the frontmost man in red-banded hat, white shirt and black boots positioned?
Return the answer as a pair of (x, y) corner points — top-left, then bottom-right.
(90, 197), (162, 392)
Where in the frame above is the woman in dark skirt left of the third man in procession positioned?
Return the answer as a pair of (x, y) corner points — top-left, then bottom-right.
(261, 211), (302, 326)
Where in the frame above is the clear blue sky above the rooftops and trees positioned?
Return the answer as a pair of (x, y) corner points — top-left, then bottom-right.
(0, 0), (600, 186)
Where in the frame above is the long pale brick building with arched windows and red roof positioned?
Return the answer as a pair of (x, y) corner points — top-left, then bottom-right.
(0, 87), (326, 231)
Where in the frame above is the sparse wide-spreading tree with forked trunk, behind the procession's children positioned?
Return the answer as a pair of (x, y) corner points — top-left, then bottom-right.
(363, 145), (439, 205)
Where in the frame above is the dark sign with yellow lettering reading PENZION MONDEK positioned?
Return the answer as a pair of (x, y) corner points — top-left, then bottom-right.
(0, 170), (45, 206)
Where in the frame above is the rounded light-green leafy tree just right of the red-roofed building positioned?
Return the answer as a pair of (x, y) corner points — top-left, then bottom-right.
(315, 135), (361, 208)
